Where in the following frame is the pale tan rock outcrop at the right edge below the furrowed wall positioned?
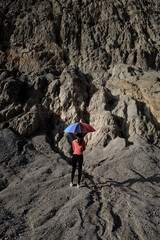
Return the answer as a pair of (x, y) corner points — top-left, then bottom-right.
(106, 64), (160, 146)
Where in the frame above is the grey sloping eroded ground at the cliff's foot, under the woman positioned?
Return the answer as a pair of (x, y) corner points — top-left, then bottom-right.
(0, 129), (160, 240)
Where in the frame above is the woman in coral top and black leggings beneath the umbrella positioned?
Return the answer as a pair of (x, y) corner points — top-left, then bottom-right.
(70, 133), (86, 188)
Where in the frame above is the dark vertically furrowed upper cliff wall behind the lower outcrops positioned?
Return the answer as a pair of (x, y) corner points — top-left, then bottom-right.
(0, 0), (160, 74)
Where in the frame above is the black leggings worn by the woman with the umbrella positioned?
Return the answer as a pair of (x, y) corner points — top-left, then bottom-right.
(71, 154), (83, 184)
